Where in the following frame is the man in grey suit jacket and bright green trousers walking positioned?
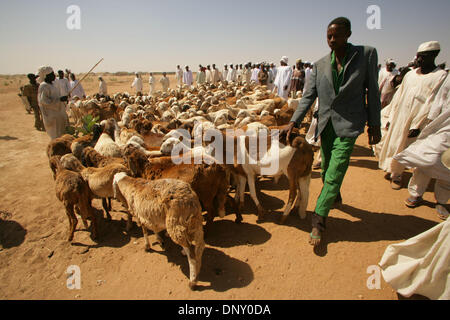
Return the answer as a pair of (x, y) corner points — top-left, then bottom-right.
(281, 17), (381, 246)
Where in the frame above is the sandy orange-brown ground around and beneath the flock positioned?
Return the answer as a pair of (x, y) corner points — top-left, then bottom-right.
(0, 76), (440, 299)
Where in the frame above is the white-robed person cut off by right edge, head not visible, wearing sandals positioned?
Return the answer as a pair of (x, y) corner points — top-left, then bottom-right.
(394, 75), (450, 220)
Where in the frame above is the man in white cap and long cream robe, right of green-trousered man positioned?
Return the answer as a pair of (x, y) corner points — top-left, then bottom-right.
(375, 41), (447, 190)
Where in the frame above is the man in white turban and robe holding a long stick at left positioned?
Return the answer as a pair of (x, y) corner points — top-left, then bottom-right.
(38, 66), (69, 139)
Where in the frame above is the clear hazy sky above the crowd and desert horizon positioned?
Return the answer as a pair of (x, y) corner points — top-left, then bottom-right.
(0, 0), (450, 74)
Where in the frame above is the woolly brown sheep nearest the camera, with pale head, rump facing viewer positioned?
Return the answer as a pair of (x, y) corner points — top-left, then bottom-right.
(113, 173), (205, 290)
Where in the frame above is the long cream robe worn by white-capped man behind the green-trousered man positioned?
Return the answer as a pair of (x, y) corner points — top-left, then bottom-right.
(375, 68), (447, 173)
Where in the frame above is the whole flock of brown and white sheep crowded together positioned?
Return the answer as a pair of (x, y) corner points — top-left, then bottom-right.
(47, 82), (314, 289)
